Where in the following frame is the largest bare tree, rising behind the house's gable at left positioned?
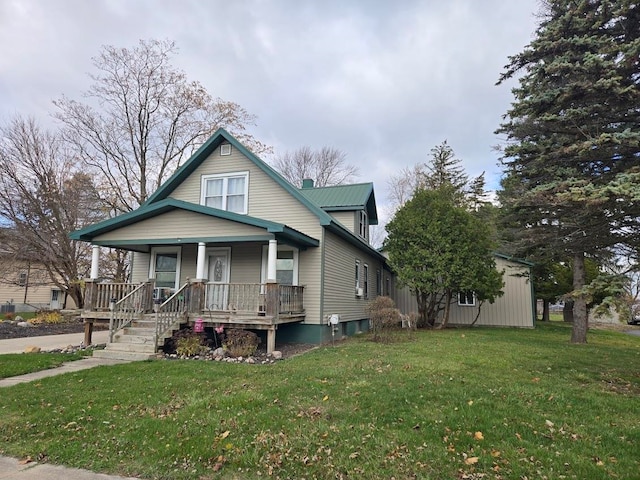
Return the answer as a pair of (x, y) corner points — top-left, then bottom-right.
(54, 40), (267, 214)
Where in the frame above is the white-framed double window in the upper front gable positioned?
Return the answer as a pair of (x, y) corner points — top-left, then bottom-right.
(200, 172), (249, 214)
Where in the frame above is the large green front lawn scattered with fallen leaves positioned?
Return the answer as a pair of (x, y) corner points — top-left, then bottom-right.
(0, 323), (640, 480)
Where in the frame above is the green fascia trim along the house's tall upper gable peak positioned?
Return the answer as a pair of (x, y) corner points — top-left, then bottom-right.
(143, 128), (331, 225)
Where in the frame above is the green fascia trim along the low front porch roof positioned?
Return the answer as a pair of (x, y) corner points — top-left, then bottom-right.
(69, 198), (320, 247)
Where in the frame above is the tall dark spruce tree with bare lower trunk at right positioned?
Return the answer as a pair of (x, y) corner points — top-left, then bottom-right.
(498, 0), (640, 343)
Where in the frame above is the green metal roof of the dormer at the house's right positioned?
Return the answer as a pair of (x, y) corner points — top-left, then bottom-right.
(298, 183), (378, 225)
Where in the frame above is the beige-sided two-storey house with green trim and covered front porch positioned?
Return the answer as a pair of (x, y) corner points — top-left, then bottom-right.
(71, 129), (393, 354)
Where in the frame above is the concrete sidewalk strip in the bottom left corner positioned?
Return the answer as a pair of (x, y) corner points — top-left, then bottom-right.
(0, 456), (140, 480)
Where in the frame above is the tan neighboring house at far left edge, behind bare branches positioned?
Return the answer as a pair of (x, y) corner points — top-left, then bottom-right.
(0, 256), (75, 313)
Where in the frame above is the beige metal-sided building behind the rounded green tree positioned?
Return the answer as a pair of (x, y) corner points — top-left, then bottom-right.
(395, 254), (536, 327)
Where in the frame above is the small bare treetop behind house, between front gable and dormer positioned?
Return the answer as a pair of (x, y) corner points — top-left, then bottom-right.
(273, 147), (358, 187)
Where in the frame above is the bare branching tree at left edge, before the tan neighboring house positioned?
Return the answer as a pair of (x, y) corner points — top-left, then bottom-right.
(0, 118), (105, 307)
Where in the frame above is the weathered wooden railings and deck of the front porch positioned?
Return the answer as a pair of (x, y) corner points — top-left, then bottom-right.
(83, 280), (305, 353)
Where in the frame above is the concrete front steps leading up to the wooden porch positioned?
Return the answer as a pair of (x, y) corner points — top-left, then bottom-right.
(93, 320), (179, 360)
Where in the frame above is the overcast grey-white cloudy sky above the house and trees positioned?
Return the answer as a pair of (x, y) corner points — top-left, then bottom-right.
(0, 0), (538, 221)
